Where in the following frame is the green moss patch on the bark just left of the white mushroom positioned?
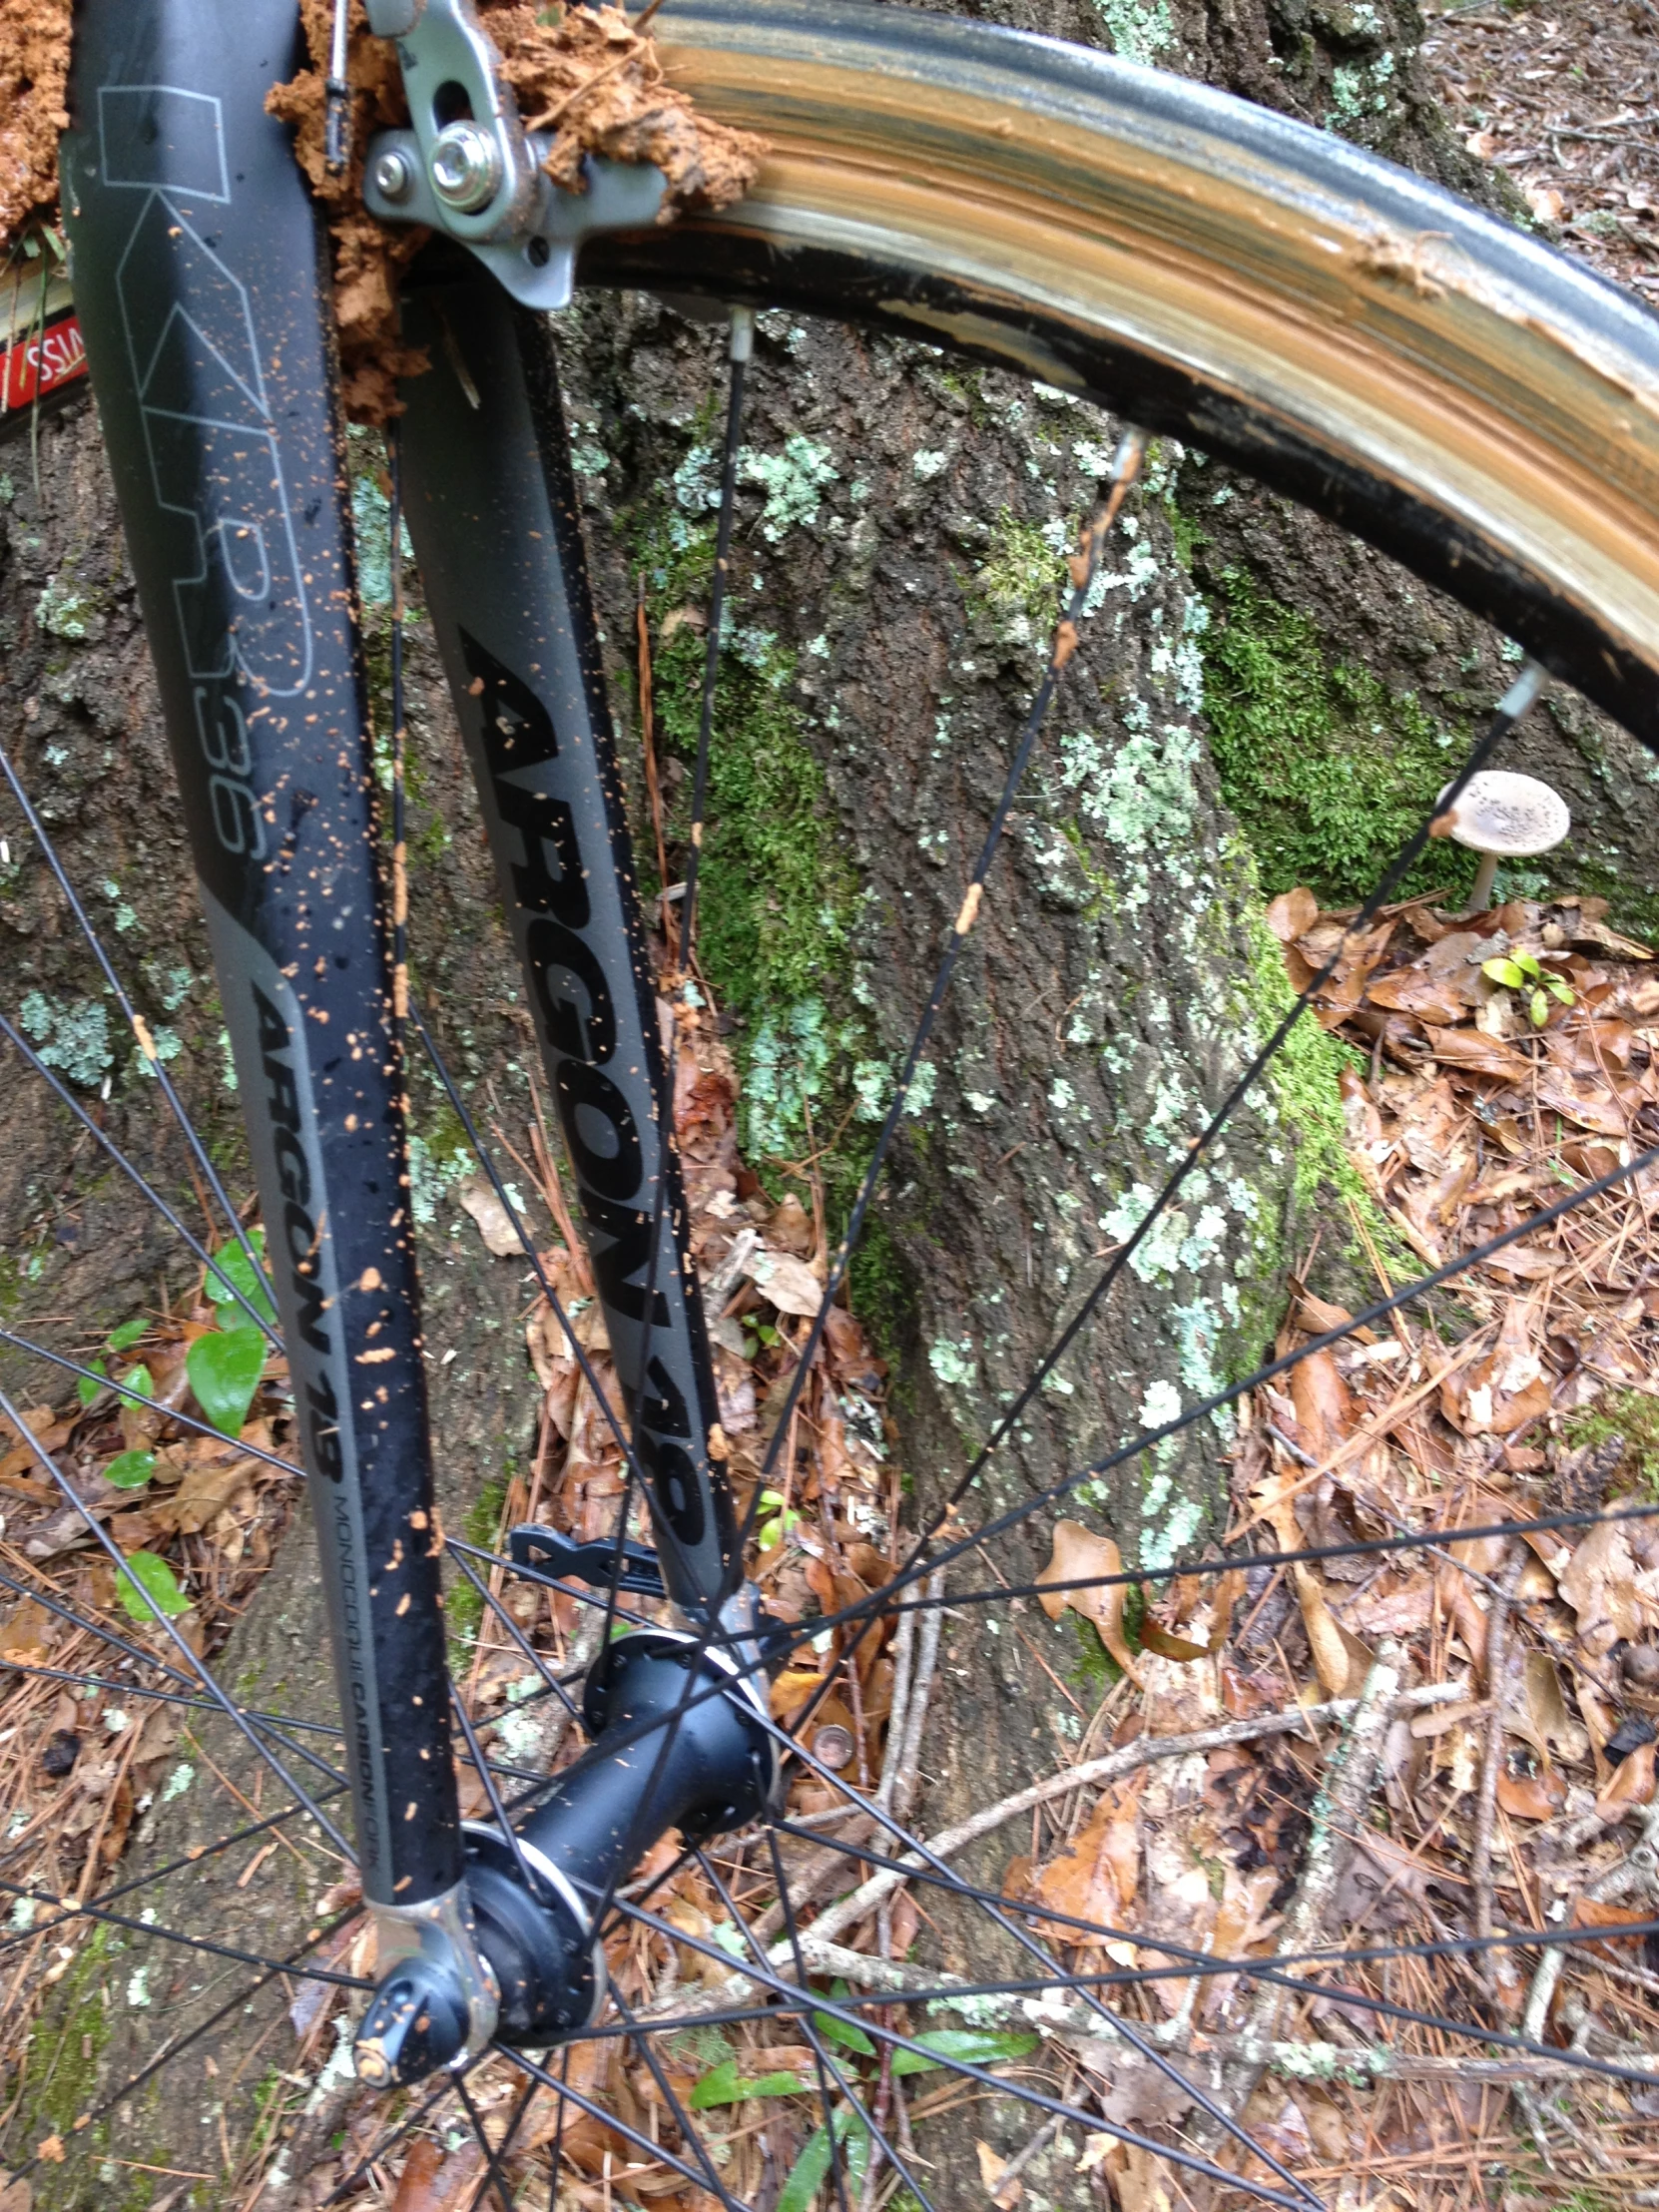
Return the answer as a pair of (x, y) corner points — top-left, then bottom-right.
(1204, 569), (1475, 904)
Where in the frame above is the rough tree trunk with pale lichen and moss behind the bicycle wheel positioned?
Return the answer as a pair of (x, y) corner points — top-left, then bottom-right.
(0, 0), (1659, 2203)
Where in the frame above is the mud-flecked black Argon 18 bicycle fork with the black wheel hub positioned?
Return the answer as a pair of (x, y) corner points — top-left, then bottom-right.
(62, 0), (775, 2079)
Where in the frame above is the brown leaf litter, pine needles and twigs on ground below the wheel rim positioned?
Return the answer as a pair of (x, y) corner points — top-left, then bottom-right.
(0, 891), (1659, 2212)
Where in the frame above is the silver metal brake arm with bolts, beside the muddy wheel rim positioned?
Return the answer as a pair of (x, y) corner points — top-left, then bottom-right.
(362, 0), (668, 311)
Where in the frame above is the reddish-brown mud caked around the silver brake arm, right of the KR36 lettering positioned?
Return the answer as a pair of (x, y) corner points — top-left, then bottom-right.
(268, 0), (766, 424)
